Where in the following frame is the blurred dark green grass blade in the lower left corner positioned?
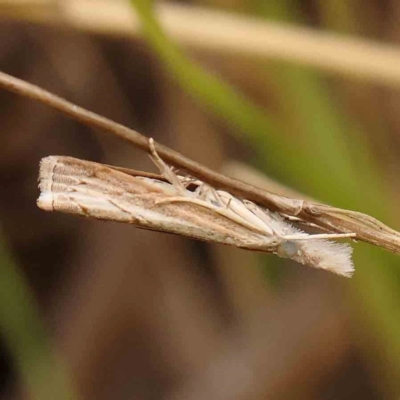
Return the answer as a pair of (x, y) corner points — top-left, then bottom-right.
(0, 232), (78, 400)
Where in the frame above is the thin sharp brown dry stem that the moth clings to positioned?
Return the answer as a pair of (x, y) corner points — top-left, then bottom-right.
(0, 71), (400, 253)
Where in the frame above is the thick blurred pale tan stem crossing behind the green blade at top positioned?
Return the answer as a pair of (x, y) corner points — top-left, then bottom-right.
(0, 0), (400, 86)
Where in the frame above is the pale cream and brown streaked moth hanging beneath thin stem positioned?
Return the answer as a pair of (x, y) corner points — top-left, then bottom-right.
(37, 139), (355, 277)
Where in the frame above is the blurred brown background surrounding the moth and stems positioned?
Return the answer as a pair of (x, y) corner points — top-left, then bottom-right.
(0, 0), (400, 400)
